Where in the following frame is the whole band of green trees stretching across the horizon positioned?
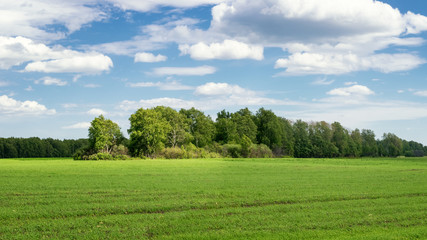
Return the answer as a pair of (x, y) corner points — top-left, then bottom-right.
(0, 106), (427, 160)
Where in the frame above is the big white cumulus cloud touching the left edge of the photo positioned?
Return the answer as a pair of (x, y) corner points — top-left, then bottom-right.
(0, 36), (113, 73)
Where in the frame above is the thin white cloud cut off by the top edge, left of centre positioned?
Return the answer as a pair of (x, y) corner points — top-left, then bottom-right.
(108, 0), (224, 12)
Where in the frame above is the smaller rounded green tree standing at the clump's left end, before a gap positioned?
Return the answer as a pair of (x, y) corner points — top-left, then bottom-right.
(89, 115), (124, 153)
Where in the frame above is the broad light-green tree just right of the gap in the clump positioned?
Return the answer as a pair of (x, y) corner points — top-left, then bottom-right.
(128, 108), (172, 157)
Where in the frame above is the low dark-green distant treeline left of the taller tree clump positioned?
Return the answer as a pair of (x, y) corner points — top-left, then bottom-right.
(0, 137), (88, 158)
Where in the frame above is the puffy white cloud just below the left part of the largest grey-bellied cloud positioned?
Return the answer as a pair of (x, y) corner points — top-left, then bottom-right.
(179, 40), (264, 60)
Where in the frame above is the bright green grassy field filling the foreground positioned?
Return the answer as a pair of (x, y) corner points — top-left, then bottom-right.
(0, 158), (427, 239)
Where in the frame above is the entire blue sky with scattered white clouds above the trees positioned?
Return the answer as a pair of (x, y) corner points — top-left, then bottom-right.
(0, 0), (427, 145)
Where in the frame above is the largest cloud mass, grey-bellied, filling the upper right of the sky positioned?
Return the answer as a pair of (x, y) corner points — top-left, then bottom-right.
(209, 0), (427, 75)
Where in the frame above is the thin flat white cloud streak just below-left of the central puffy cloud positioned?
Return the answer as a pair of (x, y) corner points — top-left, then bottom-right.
(151, 65), (216, 76)
